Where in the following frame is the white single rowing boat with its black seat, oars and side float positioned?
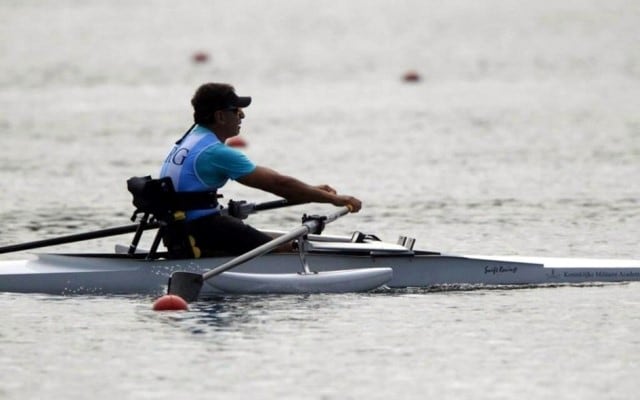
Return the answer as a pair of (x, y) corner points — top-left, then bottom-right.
(0, 182), (640, 301)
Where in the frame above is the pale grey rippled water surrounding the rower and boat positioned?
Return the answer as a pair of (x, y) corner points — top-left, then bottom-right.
(0, 0), (640, 399)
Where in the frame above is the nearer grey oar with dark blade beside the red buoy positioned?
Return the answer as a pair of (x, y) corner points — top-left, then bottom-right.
(167, 207), (349, 302)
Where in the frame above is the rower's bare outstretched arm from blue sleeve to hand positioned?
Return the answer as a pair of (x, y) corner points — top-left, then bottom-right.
(237, 166), (362, 212)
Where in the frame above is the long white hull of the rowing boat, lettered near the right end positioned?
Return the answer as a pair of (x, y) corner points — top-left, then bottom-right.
(0, 230), (640, 296)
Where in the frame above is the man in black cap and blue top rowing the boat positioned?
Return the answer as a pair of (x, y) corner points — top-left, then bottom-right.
(160, 83), (362, 256)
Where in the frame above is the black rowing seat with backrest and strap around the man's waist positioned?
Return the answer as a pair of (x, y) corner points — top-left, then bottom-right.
(127, 176), (222, 259)
